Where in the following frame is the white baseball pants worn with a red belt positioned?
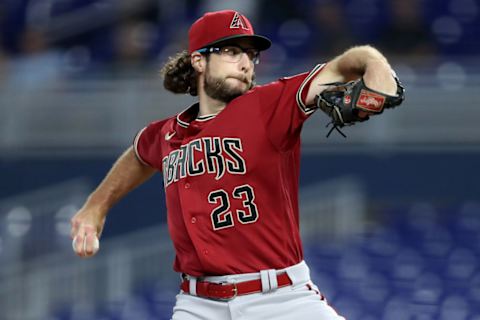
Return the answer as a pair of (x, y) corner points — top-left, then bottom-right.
(172, 261), (345, 320)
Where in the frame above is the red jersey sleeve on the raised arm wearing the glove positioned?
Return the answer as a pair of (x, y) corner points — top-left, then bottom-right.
(258, 64), (324, 151)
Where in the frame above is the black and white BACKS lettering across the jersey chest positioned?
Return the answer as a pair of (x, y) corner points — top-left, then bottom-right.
(162, 137), (247, 188)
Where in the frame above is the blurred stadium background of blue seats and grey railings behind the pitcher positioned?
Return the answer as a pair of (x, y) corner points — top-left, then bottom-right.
(0, 0), (480, 320)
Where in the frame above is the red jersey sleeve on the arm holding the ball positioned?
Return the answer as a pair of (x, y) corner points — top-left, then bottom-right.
(133, 120), (166, 171)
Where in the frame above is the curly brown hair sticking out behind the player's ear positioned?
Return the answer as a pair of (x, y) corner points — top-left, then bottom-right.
(160, 50), (198, 96)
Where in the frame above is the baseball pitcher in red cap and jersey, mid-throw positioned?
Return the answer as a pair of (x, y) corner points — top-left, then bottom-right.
(71, 10), (404, 320)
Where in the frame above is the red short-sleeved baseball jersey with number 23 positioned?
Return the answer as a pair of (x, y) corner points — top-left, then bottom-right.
(134, 65), (323, 276)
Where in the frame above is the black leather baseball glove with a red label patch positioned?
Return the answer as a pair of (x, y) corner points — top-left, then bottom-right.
(315, 76), (405, 137)
